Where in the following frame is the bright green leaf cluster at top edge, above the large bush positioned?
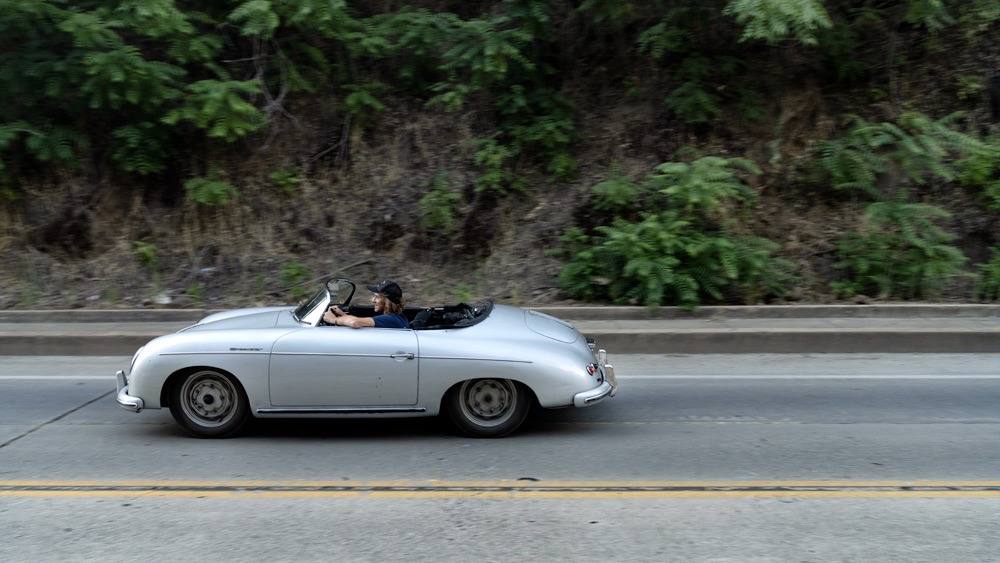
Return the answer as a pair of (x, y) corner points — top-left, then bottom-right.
(723, 0), (832, 45)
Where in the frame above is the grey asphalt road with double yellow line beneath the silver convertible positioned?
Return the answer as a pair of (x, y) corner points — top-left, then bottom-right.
(0, 354), (1000, 562)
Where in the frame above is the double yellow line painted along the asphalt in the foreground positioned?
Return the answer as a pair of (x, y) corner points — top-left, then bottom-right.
(0, 480), (1000, 500)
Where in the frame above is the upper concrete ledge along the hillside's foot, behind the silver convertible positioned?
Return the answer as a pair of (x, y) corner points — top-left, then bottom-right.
(0, 303), (1000, 323)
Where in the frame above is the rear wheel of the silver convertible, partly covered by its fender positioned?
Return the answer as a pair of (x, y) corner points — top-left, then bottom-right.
(447, 379), (533, 438)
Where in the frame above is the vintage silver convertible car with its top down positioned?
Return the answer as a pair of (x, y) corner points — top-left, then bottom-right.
(117, 279), (618, 437)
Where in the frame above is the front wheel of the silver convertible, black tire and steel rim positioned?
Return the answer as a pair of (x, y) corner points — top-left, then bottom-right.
(170, 368), (250, 438)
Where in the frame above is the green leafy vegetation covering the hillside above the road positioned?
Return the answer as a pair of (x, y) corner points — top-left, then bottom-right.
(0, 0), (1000, 307)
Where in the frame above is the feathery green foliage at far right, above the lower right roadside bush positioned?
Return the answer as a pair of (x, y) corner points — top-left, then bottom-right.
(818, 112), (986, 199)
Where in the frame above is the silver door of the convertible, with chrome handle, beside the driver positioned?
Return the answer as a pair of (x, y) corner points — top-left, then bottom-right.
(268, 326), (418, 407)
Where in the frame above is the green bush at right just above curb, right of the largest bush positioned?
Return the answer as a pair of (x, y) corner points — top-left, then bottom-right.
(832, 200), (966, 299)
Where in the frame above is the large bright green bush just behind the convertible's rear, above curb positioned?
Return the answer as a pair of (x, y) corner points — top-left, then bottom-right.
(560, 157), (791, 308)
